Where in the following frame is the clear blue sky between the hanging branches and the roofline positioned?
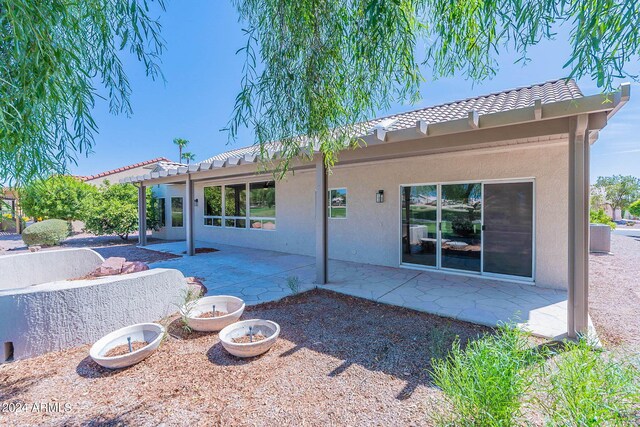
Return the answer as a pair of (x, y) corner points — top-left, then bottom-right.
(71, 0), (640, 179)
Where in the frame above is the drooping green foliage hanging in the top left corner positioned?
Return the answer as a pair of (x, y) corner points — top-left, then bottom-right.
(0, 0), (164, 184)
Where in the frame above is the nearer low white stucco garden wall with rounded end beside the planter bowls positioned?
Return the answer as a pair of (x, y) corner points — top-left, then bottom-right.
(0, 251), (187, 363)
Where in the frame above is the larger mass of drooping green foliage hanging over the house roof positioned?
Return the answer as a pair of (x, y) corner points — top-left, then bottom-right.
(228, 0), (640, 172)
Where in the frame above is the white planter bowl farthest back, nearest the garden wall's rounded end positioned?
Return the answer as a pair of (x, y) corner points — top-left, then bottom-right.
(181, 295), (245, 332)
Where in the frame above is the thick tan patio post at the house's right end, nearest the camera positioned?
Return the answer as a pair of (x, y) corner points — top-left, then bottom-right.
(567, 114), (590, 338)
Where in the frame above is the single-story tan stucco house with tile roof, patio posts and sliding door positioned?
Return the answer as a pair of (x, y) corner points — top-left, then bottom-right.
(123, 79), (630, 342)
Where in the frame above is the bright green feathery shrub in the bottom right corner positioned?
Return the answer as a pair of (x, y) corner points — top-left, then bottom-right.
(540, 340), (640, 427)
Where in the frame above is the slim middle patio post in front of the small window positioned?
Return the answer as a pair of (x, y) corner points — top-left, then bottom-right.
(316, 155), (329, 285)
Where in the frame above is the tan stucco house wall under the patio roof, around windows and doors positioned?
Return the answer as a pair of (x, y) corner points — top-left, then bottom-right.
(154, 142), (568, 288)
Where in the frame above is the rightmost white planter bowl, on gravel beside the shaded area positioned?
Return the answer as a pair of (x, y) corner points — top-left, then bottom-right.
(219, 319), (280, 357)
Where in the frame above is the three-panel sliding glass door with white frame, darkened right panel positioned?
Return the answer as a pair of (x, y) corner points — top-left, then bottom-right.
(400, 181), (534, 279)
